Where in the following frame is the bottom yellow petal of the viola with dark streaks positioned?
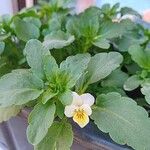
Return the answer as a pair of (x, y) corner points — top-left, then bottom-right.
(73, 109), (89, 128)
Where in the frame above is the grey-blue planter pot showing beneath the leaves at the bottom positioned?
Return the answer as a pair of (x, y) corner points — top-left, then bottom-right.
(0, 109), (132, 150)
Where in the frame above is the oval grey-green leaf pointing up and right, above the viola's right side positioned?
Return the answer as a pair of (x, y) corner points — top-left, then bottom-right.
(87, 52), (123, 84)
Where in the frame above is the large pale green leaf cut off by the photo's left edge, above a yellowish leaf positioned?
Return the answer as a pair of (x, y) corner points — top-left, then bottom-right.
(0, 69), (44, 107)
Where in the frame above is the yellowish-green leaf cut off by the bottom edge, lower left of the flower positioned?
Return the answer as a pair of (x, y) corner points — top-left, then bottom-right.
(34, 122), (73, 150)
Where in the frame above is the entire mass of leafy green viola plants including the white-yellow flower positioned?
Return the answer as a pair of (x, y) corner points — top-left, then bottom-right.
(0, 1), (150, 150)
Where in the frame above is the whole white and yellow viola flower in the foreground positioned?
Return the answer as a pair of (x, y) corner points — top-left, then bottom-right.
(65, 92), (95, 128)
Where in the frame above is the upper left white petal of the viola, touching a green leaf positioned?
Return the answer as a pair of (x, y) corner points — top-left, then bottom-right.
(72, 92), (83, 106)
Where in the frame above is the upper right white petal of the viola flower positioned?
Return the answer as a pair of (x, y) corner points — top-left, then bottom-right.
(80, 93), (95, 106)
